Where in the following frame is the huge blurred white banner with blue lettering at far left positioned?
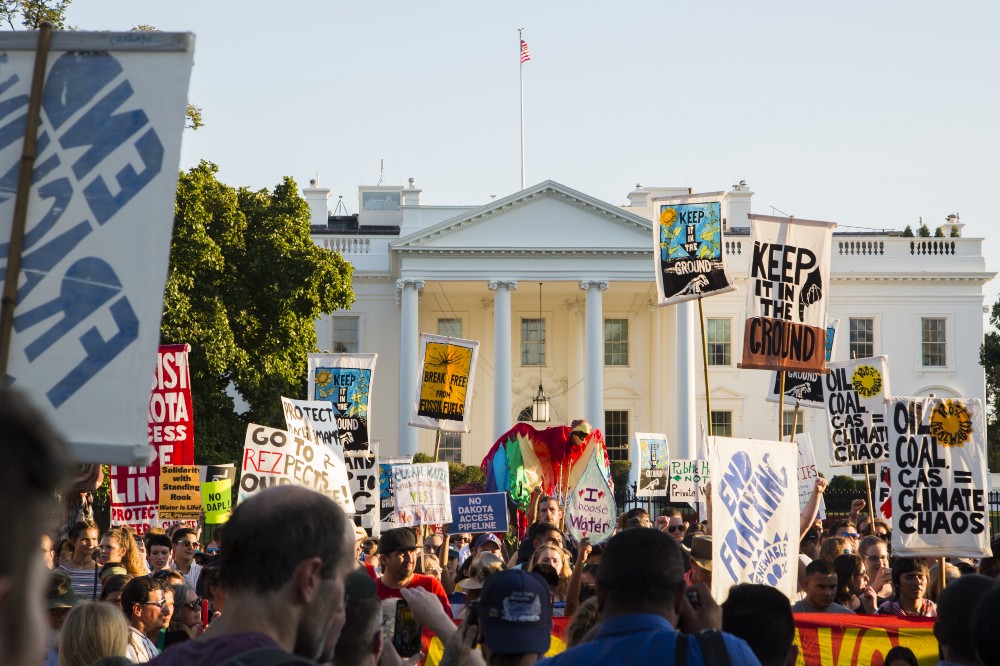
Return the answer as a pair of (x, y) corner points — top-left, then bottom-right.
(0, 31), (194, 465)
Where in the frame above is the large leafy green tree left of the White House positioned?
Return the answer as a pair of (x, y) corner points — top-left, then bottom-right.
(160, 161), (354, 463)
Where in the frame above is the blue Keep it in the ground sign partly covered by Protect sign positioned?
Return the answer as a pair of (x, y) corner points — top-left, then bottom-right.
(309, 354), (378, 451)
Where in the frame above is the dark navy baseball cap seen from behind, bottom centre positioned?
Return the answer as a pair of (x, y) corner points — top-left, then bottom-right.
(479, 569), (552, 654)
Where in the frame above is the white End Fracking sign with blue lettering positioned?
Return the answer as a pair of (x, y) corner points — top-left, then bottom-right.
(709, 437), (799, 599)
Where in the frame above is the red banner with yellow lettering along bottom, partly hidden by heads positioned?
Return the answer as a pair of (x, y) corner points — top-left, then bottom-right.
(421, 613), (938, 666)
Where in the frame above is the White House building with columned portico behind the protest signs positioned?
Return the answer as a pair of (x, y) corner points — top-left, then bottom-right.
(304, 179), (994, 476)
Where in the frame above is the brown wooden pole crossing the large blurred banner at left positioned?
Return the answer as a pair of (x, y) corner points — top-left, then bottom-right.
(0, 23), (52, 388)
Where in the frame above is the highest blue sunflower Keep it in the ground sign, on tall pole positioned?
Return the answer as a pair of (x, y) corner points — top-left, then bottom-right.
(653, 192), (736, 305)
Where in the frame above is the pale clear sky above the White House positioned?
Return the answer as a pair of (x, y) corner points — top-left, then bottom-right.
(68, 0), (1000, 305)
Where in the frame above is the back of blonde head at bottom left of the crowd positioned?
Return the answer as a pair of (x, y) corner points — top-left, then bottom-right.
(59, 601), (129, 666)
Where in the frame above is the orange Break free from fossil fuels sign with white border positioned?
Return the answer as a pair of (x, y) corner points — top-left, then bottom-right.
(410, 333), (479, 432)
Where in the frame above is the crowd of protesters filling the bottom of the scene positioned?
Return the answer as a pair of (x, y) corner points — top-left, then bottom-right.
(0, 392), (1000, 666)
